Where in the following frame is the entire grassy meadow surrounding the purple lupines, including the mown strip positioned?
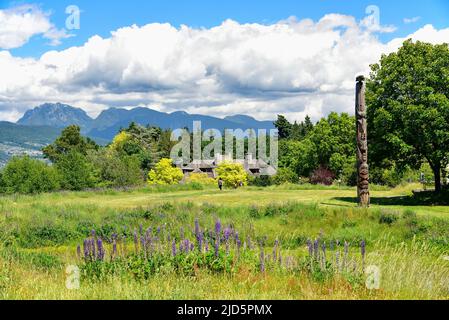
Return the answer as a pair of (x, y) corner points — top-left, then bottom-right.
(0, 185), (449, 299)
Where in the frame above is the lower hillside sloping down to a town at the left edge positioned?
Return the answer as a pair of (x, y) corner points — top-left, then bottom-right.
(0, 122), (61, 167)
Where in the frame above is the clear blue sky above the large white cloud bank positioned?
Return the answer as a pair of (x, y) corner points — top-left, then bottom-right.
(0, 0), (449, 57)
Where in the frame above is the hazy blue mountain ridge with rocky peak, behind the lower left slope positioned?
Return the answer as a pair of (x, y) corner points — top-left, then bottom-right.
(18, 103), (274, 141)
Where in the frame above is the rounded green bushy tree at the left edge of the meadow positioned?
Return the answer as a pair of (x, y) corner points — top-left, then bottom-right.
(0, 156), (60, 194)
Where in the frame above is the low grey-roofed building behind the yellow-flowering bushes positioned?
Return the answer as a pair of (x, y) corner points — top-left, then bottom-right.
(178, 154), (276, 179)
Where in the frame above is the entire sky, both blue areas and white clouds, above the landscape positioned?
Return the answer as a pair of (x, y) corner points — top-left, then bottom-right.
(0, 0), (449, 121)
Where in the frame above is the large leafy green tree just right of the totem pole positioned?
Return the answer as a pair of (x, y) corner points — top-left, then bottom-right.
(367, 40), (449, 192)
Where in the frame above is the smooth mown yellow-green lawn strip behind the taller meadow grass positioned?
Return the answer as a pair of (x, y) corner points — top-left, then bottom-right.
(4, 184), (449, 219)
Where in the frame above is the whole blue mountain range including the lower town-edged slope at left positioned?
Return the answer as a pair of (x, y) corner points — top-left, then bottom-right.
(0, 103), (274, 166)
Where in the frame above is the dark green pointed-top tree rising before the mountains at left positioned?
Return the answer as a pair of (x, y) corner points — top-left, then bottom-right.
(42, 125), (99, 163)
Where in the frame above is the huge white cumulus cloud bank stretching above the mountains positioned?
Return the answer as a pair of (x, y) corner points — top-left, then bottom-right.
(0, 14), (449, 120)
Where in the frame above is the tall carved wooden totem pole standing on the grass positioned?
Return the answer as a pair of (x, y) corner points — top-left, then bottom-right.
(355, 76), (370, 207)
